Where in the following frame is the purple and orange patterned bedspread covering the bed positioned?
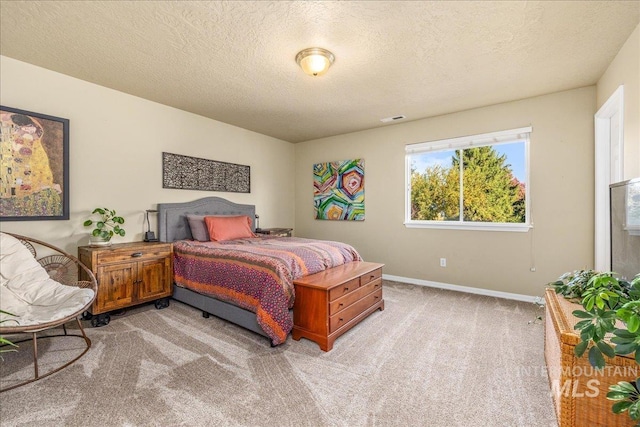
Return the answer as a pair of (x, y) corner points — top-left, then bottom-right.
(173, 236), (362, 345)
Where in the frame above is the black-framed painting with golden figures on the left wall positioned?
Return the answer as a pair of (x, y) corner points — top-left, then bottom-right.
(0, 106), (69, 221)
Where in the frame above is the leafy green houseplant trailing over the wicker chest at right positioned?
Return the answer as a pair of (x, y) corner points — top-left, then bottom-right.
(549, 270), (640, 426)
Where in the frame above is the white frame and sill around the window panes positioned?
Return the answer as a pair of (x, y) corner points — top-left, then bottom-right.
(404, 126), (533, 232)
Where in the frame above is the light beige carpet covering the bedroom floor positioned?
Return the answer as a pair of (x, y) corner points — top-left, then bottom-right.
(0, 281), (557, 427)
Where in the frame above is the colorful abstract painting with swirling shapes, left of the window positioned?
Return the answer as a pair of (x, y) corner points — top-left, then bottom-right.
(313, 159), (364, 221)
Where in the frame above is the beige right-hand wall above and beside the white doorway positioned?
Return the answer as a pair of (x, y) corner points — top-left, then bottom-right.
(597, 25), (640, 179)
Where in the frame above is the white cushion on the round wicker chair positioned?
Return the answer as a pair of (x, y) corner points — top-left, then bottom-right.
(0, 233), (94, 327)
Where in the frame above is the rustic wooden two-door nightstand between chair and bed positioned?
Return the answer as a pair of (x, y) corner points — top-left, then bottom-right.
(78, 242), (173, 326)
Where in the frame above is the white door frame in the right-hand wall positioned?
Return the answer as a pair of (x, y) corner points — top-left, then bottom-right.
(594, 85), (624, 271)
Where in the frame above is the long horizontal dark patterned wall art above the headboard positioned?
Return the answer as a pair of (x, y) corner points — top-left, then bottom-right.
(162, 153), (251, 193)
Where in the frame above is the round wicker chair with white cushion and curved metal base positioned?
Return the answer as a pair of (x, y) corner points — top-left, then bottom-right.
(0, 232), (98, 393)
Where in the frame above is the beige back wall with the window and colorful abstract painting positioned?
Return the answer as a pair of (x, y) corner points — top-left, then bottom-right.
(295, 86), (596, 296)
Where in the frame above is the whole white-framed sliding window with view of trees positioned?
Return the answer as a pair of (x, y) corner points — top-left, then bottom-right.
(405, 127), (531, 231)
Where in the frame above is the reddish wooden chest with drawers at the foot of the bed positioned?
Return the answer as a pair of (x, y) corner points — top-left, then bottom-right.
(291, 261), (384, 351)
